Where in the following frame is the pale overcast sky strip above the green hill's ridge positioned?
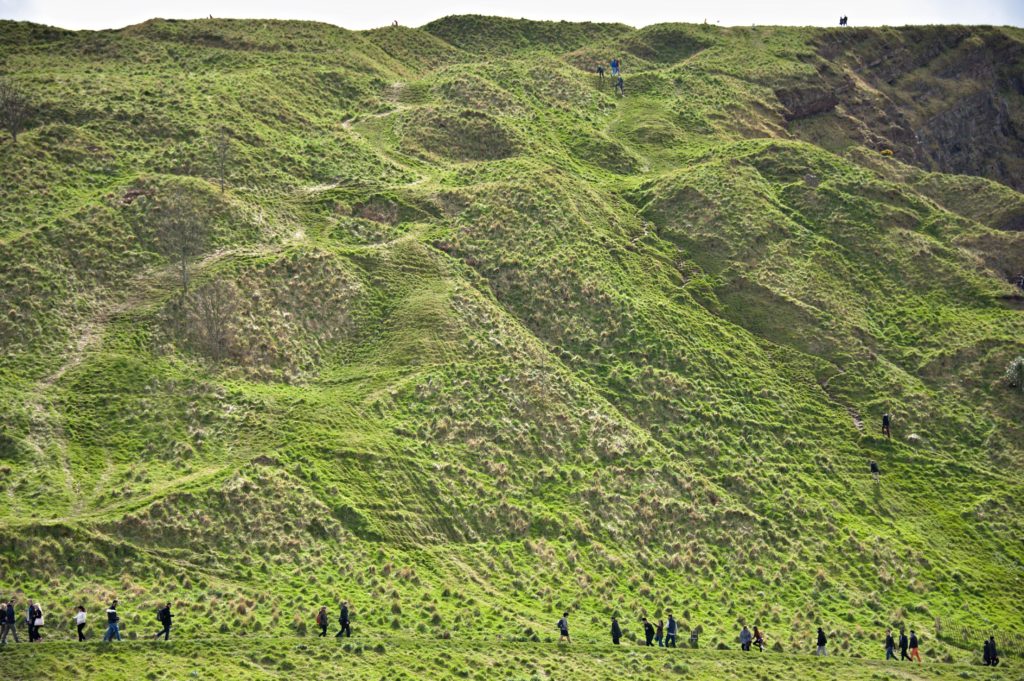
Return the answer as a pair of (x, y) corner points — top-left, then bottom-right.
(0, 0), (1024, 29)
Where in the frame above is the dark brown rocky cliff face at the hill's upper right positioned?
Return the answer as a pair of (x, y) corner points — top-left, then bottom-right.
(790, 27), (1024, 190)
